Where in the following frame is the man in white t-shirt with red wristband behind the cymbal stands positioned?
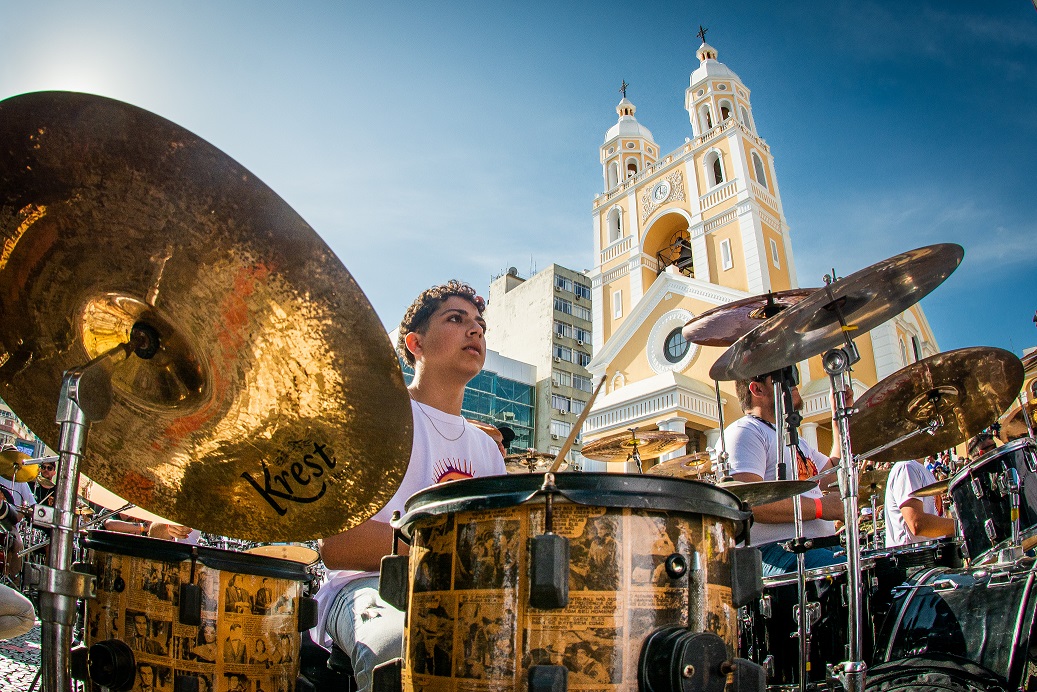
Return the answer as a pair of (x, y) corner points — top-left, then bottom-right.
(724, 368), (844, 577)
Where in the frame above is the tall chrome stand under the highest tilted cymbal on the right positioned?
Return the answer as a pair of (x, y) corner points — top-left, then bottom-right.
(821, 331), (868, 692)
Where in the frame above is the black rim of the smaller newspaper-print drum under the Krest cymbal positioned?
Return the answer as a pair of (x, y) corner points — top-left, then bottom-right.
(83, 529), (313, 582)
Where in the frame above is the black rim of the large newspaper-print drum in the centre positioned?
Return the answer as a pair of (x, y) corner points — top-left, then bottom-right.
(392, 472), (752, 536)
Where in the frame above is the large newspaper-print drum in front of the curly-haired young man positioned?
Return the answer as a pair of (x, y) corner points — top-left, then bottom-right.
(396, 473), (749, 692)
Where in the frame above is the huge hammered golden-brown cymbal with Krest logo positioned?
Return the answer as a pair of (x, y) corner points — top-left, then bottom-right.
(0, 92), (412, 541)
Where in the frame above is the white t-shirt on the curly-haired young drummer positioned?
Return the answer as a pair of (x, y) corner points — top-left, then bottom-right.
(310, 399), (507, 646)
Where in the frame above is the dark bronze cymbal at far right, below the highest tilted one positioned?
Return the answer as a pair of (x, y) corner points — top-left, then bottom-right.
(849, 347), (1022, 462)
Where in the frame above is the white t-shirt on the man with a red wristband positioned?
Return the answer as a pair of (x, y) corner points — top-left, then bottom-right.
(724, 416), (835, 546)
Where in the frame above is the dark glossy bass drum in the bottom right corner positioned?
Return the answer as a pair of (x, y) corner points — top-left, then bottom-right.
(868, 559), (1037, 690)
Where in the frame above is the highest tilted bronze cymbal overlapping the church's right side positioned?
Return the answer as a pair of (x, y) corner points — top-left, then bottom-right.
(709, 244), (964, 380)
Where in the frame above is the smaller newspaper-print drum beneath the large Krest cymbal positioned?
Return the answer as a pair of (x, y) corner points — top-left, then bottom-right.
(85, 531), (309, 692)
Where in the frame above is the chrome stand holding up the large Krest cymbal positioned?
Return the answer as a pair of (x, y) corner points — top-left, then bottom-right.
(33, 325), (159, 692)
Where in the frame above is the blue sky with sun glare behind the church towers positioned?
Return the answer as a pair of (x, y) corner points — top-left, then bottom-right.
(6, 0), (1037, 363)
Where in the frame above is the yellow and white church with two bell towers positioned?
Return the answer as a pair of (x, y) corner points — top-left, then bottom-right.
(584, 32), (938, 471)
